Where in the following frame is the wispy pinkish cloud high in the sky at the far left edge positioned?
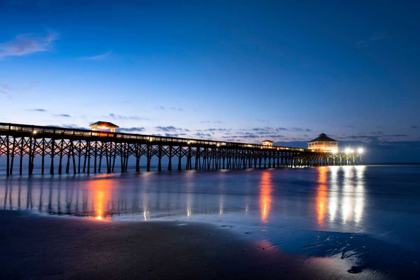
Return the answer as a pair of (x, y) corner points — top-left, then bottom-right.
(0, 31), (58, 59)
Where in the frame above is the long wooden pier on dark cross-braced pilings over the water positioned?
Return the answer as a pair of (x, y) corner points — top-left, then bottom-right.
(0, 123), (361, 176)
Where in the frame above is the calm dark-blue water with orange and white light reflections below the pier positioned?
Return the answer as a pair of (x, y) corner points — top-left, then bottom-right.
(0, 165), (420, 277)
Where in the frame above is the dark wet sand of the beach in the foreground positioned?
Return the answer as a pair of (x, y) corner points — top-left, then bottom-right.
(0, 211), (378, 279)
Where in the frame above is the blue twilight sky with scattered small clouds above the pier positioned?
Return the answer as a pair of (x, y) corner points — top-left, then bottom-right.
(0, 0), (420, 161)
